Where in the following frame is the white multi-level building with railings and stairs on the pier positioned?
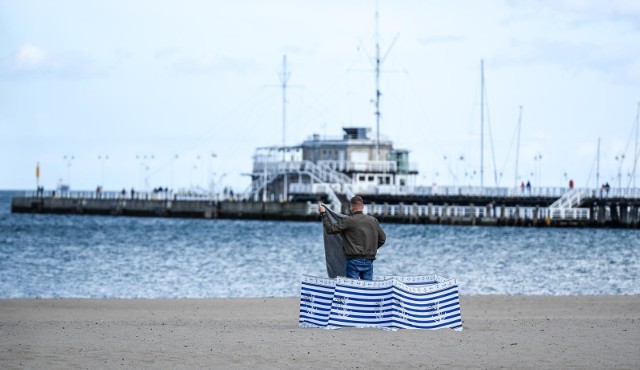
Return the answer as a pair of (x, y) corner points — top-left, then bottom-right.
(246, 127), (418, 205)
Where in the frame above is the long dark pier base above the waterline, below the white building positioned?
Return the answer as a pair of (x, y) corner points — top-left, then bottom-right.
(11, 192), (640, 228)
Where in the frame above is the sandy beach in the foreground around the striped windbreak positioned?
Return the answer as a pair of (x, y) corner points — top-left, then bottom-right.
(0, 296), (640, 369)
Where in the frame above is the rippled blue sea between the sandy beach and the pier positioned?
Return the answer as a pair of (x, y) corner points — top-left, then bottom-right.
(0, 191), (640, 298)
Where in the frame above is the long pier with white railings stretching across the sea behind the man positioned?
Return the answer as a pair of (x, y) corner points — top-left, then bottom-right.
(11, 187), (640, 228)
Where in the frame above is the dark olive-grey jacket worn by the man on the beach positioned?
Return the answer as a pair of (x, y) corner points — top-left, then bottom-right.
(322, 212), (387, 260)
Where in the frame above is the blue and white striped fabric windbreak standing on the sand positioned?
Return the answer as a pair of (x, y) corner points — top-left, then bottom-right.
(299, 275), (462, 330)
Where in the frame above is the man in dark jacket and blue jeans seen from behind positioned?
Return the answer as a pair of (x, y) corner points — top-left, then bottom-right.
(318, 195), (387, 280)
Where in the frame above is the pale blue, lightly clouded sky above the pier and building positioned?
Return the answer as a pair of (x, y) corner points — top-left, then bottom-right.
(0, 0), (640, 192)
